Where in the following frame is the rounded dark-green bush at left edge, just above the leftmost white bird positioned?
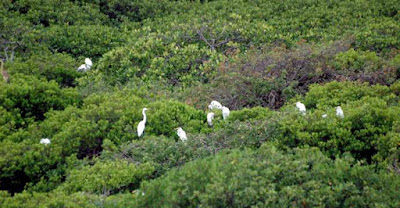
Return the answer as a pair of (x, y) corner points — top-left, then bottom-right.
(0, 74), (80, 132)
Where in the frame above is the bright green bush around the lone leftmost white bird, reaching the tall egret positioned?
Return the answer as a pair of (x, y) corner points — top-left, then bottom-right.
(0, 92), (142, 192)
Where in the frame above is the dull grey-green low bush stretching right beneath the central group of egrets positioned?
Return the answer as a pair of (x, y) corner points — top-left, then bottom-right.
(110, 116), (273, 177)
